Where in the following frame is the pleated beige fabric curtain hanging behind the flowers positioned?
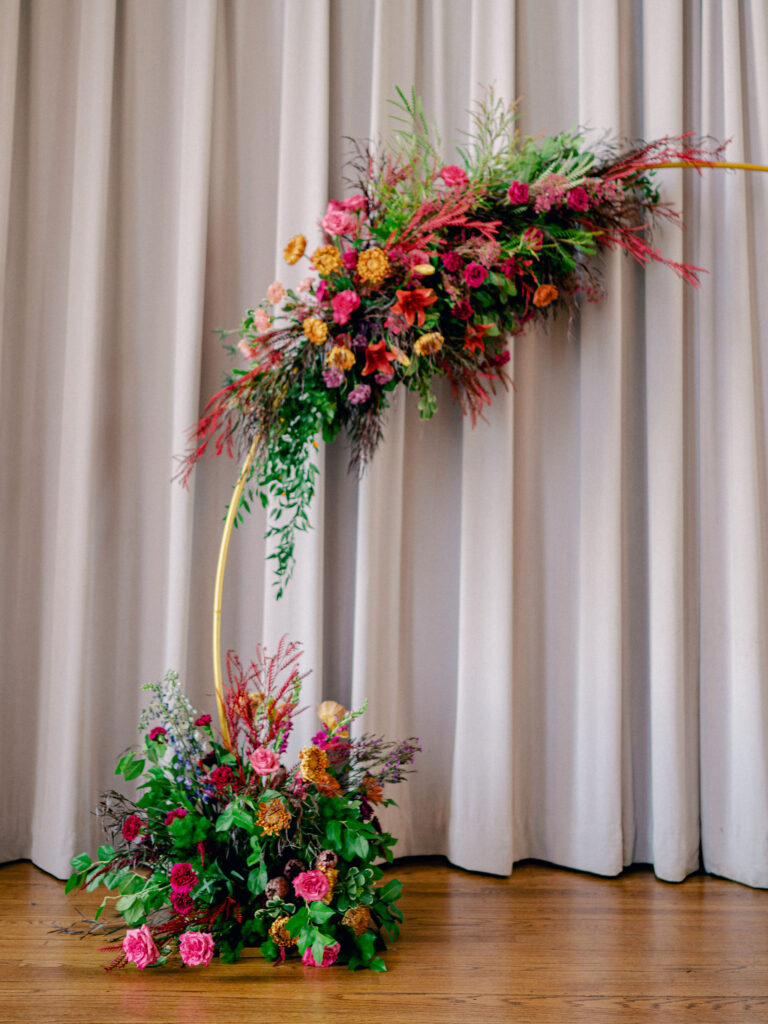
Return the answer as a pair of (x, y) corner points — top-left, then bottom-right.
(0, 0), (768, 887)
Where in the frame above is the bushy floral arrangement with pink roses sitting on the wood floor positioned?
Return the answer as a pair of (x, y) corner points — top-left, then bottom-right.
(67, 640), (419, 971)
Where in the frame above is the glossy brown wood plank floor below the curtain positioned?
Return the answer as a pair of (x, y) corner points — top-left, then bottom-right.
(0, 859), (768, 1024)
